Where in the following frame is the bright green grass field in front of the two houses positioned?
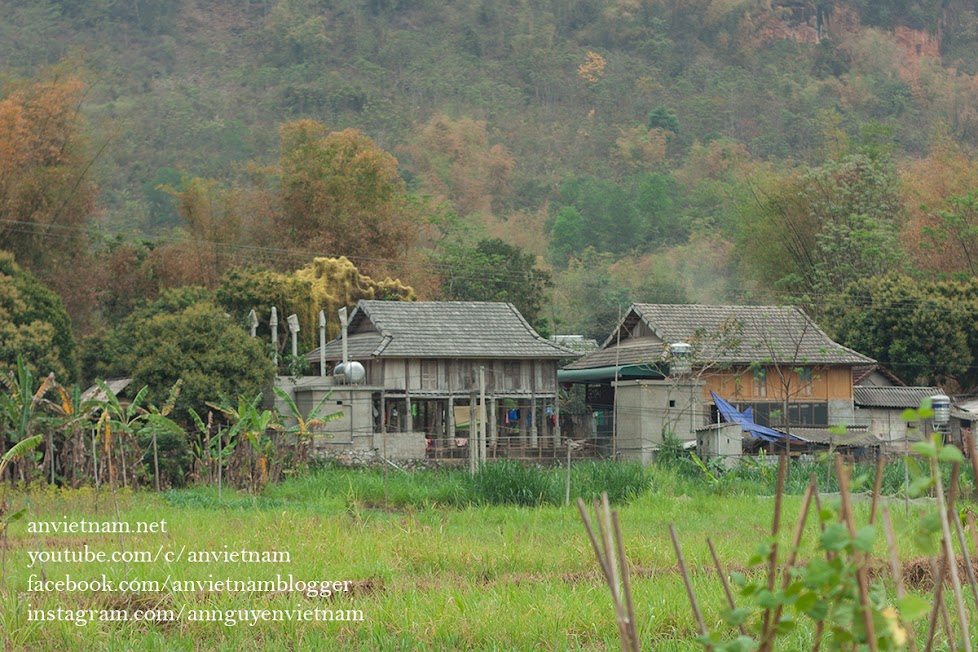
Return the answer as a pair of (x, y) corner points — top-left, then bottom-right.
(0, 464), (974, 651)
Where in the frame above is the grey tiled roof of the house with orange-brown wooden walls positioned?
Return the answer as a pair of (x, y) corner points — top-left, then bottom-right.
(567, 303), (875, 369)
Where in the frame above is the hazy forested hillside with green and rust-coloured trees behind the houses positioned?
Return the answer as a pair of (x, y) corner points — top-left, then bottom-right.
(0, 0), (978, 386)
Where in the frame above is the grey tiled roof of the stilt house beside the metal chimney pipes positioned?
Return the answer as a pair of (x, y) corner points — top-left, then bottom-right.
(306, 301), (579, 360)
